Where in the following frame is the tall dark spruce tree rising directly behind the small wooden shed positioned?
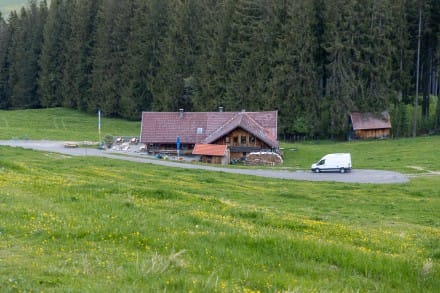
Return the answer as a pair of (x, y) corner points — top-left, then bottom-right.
(352, 1), (397, 112)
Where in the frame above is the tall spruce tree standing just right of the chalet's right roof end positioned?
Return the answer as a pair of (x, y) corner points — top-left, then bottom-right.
(271, 1), (321, 135)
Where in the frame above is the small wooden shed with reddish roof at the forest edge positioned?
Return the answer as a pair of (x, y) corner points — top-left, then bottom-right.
(350, 112), (391, 139)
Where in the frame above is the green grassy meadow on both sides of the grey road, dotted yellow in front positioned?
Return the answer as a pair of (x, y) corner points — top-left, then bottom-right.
(0, 109), (440, 292)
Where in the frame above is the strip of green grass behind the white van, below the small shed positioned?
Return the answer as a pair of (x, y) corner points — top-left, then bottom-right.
(281, 136), (440, 173)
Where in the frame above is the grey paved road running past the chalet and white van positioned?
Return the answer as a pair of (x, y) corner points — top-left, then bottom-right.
(0, 140), (409, 184)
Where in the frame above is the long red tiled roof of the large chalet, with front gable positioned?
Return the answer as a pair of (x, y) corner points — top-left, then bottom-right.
(141, 111), (278, 147)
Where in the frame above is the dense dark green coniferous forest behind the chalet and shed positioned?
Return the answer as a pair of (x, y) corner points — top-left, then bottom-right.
(0, 0), (440, 139)
